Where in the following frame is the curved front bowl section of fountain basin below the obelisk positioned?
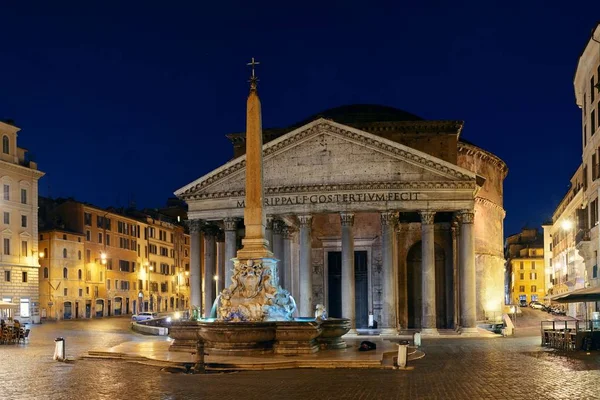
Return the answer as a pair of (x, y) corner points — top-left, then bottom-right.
(196, 321), (276, 355)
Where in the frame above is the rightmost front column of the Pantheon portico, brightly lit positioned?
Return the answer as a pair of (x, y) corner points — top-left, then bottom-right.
(458, 210), (477, 333)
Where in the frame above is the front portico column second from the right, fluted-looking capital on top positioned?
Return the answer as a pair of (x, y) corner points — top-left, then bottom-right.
(420, 211), (437, 334)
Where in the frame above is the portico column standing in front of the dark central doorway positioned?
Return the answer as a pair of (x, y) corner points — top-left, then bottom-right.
(340, 212), (356, 333)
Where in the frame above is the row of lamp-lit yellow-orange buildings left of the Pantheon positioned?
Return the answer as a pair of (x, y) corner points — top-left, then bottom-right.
(40, 199), (189, 319)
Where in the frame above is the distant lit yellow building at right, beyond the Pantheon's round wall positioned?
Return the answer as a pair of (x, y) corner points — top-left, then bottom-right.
(506, 228), (546, 304)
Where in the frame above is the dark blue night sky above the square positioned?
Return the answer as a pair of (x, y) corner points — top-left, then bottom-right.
(0, 0), (600, 234)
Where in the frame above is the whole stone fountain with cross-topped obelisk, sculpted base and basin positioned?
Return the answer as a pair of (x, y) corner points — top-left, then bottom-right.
(170, 59), (350, 355)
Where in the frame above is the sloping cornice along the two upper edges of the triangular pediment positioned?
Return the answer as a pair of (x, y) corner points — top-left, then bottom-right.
(178, 120), (473, 199)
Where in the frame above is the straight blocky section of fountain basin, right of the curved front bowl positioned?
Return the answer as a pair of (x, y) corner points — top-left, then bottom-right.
(273, 320), (321, 354)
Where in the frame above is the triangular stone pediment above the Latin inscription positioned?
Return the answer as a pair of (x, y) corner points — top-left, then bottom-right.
(175, 119), (476, 199)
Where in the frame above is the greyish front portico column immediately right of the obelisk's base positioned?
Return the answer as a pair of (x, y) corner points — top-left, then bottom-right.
(298, 215), (314, 317)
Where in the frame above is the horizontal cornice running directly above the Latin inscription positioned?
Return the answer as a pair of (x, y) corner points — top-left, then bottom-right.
(186, 181), (477, 200)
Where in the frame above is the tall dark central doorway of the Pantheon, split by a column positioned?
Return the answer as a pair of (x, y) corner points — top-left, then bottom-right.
(327, 251), (369, 328)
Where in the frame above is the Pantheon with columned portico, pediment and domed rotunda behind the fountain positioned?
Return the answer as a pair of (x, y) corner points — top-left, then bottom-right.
(176, 105), (508, 334)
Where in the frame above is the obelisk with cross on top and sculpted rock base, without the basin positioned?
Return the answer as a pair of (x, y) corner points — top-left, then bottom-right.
(218, 58), (296, 322)
